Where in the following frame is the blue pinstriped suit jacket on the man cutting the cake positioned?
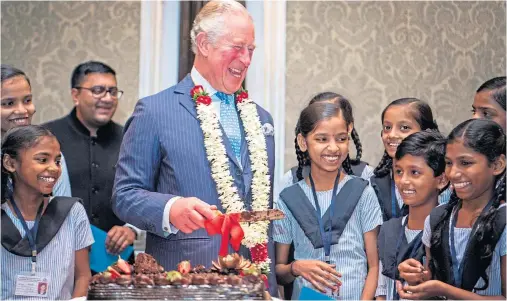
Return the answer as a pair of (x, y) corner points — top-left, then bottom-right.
(112, 75), (277, 296)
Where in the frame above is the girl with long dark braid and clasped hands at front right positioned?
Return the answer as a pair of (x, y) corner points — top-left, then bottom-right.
(397, 119), (507, 300)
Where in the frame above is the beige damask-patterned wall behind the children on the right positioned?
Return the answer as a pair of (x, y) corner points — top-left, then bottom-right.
(285, 1), (506, 168)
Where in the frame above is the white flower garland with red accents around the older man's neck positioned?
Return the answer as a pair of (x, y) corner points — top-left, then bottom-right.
(190, 85), (271, 274)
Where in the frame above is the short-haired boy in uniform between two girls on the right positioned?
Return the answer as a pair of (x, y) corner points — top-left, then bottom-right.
(376, 130), (449, 300)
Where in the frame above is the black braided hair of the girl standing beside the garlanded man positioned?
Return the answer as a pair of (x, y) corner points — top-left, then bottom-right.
(294, 92), (363, 175)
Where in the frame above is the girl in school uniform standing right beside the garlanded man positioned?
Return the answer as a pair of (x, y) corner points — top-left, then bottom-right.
(274, 102), (382, 300)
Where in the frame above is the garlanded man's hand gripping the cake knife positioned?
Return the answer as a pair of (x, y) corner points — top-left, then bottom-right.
(169, 197), (216, 234)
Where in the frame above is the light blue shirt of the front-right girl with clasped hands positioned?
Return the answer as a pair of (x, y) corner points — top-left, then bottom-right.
(422, 204), (507, 296)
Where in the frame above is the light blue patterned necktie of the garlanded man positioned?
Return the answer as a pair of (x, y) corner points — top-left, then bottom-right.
(215, 92), (241, 162)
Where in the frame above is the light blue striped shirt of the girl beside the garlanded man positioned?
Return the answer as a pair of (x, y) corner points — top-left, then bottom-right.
(273, 175), (382, 300)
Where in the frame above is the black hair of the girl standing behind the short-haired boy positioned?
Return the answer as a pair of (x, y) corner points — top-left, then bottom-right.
(373, 97), (438, 178)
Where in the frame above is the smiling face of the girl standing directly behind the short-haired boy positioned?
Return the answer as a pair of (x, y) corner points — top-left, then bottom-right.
(382, 104), (421, 158)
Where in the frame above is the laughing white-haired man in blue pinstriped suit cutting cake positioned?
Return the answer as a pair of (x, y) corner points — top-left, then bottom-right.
(112, 0), (277, 296)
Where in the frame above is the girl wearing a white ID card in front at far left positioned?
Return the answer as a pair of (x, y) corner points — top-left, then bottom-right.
(1, 125), (93, 300)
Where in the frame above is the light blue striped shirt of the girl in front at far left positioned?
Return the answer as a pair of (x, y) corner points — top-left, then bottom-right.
(1, 198), (94, 300)
